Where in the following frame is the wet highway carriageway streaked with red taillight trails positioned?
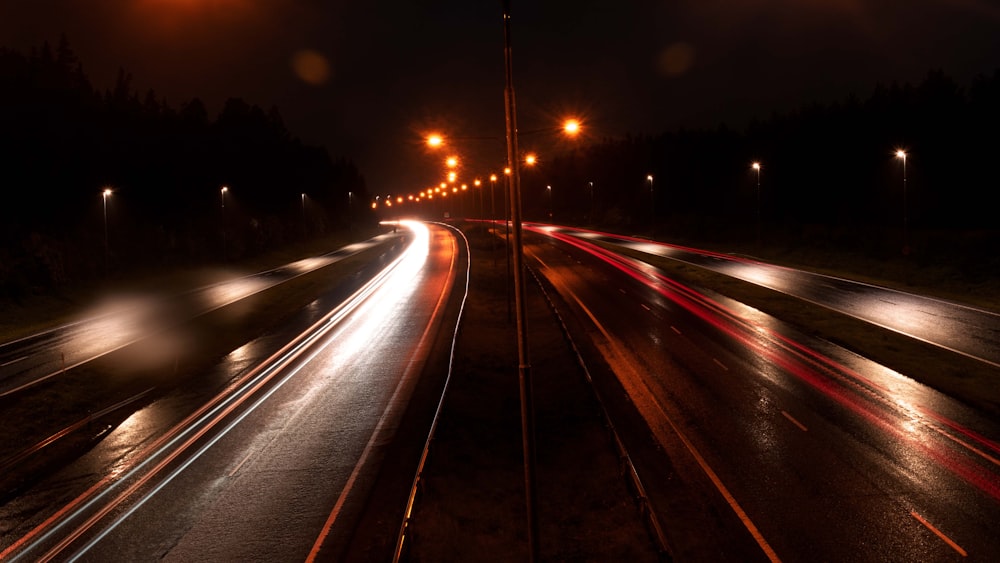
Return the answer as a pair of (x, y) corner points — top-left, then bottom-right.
(526, 225), (1000, 561)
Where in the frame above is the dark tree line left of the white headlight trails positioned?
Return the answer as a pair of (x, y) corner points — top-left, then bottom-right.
(0, 37), (372, 297)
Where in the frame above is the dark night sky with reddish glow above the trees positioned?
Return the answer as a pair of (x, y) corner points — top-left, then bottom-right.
(0, 0), (1000, 193)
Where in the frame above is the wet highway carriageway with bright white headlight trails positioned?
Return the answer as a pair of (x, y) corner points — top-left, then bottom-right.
(0, 223), (464, 561)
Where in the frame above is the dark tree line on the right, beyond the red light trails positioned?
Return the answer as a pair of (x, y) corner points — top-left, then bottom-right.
(522, 70), (1000, 264)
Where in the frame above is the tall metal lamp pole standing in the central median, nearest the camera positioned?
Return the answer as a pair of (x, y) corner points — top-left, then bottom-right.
(503, 0), (539, 561)
